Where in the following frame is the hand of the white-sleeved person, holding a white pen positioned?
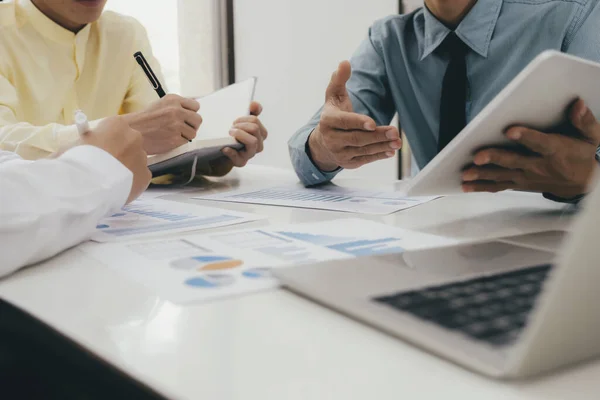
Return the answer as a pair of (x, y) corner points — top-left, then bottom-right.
(80, 117), (152, 203)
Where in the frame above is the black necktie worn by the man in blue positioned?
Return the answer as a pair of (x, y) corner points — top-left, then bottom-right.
(438, 32), (468, 151)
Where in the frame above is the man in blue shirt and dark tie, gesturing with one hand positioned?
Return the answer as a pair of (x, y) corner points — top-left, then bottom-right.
(289, 0), (600, 199)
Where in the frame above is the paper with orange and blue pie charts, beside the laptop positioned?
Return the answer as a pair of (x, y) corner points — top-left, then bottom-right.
(81, 219), (456, 303)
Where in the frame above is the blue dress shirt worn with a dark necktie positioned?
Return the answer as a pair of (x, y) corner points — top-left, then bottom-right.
(289, 0), (600, 185)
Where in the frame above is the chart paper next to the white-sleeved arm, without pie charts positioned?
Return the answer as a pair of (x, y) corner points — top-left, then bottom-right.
(92, 199), (264, 242)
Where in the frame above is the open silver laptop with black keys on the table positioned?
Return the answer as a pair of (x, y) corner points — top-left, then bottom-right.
(274, 186), (600, 379)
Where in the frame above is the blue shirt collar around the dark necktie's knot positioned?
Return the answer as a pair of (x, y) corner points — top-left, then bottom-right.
(421, 0), (503, 60)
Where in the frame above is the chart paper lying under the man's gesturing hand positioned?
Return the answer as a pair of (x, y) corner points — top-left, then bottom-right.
(194, 184), (437, 215)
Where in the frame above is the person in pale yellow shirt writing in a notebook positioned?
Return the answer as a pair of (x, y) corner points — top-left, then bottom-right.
(0, 0), (267, 175)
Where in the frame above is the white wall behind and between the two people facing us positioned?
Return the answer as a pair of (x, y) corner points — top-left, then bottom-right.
(234, 0), (398, 180)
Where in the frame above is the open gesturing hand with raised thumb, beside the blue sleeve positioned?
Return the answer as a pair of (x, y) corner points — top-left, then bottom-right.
(308, 61), (402, 171)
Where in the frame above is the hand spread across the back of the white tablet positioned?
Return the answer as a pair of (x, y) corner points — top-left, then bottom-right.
(462, 100), (600, 199)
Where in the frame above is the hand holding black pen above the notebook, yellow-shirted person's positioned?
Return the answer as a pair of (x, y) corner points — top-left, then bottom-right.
(124, 94), (202, 155)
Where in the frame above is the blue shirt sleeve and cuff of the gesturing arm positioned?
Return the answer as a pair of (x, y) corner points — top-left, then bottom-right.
(288, 21), (395, 186)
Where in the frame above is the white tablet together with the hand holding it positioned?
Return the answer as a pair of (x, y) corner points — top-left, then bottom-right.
(406, 51), (600, 198)
